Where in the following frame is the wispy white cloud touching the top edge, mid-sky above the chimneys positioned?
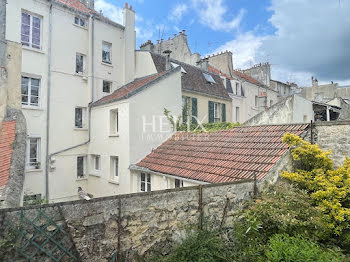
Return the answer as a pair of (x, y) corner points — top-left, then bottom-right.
(192, 0), (245, 31)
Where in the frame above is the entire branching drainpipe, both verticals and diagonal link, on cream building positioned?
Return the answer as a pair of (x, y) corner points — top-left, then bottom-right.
(45, 8), (95, 200)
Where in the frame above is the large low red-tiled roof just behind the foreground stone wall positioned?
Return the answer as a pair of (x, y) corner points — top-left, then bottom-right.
(137, 124), (308, 183)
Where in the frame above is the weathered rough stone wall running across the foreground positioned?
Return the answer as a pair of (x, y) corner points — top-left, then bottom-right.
(0, 181), (254, 262)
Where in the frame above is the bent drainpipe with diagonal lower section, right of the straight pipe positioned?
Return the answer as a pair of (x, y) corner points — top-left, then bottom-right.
(49, 16), (95, 174)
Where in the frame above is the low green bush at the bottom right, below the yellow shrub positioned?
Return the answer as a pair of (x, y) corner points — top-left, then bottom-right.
(265, 234), (345, 262)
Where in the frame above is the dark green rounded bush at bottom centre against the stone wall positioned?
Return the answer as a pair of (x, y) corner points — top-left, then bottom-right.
(152, 231), (230, 262)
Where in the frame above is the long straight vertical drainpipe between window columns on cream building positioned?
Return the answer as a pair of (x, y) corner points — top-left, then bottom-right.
(45, 3), (52, 201)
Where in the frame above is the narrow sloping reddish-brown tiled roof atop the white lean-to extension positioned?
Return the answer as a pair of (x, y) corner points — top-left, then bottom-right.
(92, 71), (169, 106)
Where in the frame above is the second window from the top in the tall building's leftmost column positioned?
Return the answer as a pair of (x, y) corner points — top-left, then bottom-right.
(21, 76), (40, 107)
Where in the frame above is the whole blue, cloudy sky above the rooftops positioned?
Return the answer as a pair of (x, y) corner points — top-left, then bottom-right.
(95, 0), (350, 86)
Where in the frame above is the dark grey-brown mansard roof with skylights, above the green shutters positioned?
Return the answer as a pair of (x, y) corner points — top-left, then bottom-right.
(151, 52), (231, 100)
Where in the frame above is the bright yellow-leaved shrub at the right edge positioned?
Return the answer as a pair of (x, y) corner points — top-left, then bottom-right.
(282, 133), (350, 235)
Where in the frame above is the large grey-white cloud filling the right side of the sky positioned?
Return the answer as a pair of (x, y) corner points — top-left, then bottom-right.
(212, 0), (350, 85)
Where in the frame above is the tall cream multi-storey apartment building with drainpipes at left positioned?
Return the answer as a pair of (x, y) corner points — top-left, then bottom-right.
(6, 0), (136, 201)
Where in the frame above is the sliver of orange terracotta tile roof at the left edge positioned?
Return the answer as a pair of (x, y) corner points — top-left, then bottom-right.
(0, 121), (16, 189)
